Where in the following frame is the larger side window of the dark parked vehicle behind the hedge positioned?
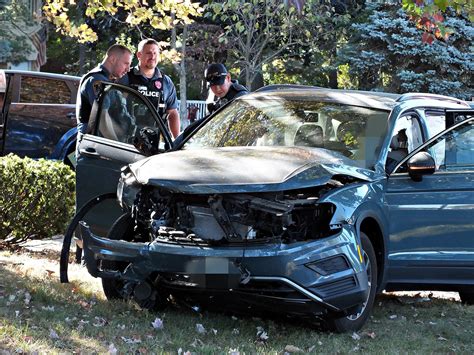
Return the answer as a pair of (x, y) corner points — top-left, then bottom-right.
(19, 76), (71, 104)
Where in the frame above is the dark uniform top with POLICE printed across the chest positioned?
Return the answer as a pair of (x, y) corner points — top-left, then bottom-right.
(120, 65), (178, 118)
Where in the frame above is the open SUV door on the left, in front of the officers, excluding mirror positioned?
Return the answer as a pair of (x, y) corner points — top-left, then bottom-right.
(76, 83), (171, 235)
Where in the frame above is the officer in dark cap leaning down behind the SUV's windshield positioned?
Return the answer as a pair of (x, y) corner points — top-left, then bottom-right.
(204, 63), (249, 113)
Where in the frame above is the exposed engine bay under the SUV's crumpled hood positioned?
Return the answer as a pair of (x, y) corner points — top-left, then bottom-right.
(132, 181), (342, 244)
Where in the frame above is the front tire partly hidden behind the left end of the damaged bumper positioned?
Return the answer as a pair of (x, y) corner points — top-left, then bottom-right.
(102, 213), (134, 300)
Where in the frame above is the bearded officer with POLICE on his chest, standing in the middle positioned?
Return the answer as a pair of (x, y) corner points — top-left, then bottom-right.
(121, 38), (180, 138)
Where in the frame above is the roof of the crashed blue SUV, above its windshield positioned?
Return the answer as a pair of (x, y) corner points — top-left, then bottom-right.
(248, 85), (469, 110)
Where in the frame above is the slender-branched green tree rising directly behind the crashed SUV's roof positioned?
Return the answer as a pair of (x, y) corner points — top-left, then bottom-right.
(205, 0), (361, 89)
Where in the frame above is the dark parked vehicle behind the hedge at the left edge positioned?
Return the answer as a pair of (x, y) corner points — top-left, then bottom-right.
(0, 70), (80, 167)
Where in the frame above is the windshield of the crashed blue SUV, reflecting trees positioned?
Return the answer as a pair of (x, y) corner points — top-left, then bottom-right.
(183, 96), (389, 168)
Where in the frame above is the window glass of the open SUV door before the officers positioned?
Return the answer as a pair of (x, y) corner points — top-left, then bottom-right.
(96, 87), (164, 148)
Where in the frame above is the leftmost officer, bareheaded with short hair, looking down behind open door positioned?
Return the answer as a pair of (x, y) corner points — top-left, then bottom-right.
(76, 44), (133, 143)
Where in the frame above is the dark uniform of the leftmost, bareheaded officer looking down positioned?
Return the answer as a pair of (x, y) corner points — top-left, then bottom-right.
(76, 64), (110, 134)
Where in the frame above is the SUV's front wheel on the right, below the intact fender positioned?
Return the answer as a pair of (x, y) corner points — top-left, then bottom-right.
(327, 232), (377, 333)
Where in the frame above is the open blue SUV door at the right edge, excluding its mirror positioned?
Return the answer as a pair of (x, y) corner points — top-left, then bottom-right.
(385, 110), (474, 285)
